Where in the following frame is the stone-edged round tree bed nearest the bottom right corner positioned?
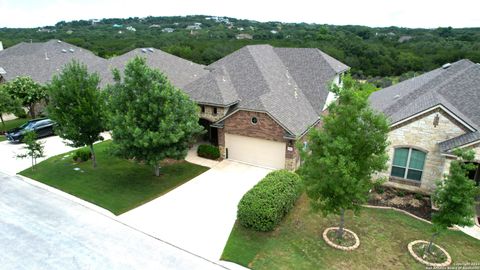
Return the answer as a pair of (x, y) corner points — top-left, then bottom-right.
(408, 240), (452, 267)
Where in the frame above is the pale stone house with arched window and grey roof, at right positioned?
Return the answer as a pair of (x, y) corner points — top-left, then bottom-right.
(370, 60), (480, 192)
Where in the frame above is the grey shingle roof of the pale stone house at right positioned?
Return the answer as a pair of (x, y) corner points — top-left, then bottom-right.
(369, 60), (480, 130)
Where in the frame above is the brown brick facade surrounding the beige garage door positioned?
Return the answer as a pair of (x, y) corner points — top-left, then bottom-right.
(218, 111), (299, 170)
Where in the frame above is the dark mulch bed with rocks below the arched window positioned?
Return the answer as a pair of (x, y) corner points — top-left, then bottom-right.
(368, 187), (435, 221)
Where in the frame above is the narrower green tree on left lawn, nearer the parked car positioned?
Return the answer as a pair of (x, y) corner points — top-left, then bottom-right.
(47, 61), (106, 168)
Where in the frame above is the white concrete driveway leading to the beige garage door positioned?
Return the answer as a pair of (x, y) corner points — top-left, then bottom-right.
(118, 160), (270, 261)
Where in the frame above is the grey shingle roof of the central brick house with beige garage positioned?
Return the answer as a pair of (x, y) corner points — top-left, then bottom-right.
(184, 45), (348, 136)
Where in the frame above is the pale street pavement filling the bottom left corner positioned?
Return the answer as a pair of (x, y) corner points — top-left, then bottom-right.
(0, 173), (225, 270)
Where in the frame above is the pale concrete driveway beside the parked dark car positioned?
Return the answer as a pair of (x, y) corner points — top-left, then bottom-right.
(0, 132), (110, 175)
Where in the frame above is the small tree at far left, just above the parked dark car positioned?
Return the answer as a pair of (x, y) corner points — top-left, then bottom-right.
(4, 77), (47, 118)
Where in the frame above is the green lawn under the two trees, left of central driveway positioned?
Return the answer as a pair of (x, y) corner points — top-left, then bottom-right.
(20, 141), (208, 215)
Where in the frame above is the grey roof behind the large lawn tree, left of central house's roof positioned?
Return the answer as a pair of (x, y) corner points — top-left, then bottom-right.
(107, 48), (208, 88)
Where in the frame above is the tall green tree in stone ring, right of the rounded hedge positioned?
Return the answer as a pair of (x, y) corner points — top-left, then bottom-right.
(299, 75), (388, 238)
